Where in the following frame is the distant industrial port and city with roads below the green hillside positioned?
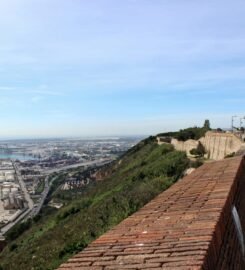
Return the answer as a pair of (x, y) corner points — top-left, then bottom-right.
(0, 138), (139, 245)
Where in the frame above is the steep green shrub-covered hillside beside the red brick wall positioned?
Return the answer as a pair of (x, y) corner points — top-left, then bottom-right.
(0, 137), (189, 270)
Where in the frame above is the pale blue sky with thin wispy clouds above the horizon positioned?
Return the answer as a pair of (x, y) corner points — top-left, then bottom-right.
(0, 0), (245, 138)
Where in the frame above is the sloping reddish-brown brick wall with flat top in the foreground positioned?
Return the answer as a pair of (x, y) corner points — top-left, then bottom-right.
(59, 157), (245, 270)
